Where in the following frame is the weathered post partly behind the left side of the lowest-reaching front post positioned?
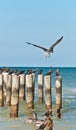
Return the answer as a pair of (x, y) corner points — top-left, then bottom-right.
(6, 74), (12, 106)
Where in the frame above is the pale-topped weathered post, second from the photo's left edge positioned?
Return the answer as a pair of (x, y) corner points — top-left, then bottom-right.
(2, 72), (8, 100)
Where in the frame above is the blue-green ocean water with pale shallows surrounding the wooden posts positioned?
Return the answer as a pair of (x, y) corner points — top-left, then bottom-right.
(0, 67), (76, 130)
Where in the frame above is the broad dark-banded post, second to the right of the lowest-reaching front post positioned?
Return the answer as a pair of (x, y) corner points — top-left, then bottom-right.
(26, 74), (34, 109)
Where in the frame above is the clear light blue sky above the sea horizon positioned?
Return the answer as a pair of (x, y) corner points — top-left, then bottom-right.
(0, 0), (76, 66)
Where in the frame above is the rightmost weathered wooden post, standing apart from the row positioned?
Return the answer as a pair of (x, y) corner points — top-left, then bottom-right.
(55, 70), (62, 118)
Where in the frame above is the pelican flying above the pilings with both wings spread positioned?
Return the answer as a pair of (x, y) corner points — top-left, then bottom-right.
(26, 36), (63, 57)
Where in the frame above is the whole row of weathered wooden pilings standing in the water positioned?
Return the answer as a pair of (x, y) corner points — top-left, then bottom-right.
(0, 72), (62, 118)
